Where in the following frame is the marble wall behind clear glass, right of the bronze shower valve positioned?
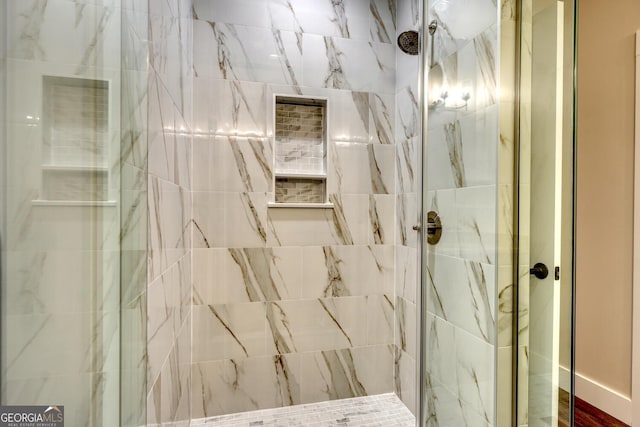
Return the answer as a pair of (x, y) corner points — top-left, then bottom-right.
(424, 0), (500, 426)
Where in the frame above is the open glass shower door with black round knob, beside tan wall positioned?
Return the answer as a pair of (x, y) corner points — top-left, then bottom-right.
(517, 0), (574, 426)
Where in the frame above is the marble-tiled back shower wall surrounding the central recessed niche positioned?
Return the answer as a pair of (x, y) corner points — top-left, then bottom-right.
(192, 0), (396, 418)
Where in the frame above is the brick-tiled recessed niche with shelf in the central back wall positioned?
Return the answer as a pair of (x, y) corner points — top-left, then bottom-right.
(271, 96), (331, 207)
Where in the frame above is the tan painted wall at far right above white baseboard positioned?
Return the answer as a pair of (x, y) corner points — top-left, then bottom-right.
(576, 0), (640, 403)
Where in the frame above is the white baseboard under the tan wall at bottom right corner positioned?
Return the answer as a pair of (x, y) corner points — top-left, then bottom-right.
(560, 366), (631, 425)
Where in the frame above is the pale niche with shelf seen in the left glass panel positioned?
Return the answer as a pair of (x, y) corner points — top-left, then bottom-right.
(39, 76), (109, 204)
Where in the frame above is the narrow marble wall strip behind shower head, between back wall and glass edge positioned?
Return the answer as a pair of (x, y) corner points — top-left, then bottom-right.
(394, 0), (422, 414)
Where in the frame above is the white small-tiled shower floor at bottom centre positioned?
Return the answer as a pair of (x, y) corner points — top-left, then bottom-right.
(191, 393), (416, 427)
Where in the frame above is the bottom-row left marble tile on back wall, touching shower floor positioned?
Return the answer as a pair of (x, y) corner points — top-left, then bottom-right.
(192, 354), (301, 418)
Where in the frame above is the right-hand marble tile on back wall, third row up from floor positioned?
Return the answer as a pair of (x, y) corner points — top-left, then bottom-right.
(302, 246), (394, 298)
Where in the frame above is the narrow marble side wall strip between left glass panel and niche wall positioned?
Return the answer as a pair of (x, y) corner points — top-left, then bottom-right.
(146, 0), (193, 425)
